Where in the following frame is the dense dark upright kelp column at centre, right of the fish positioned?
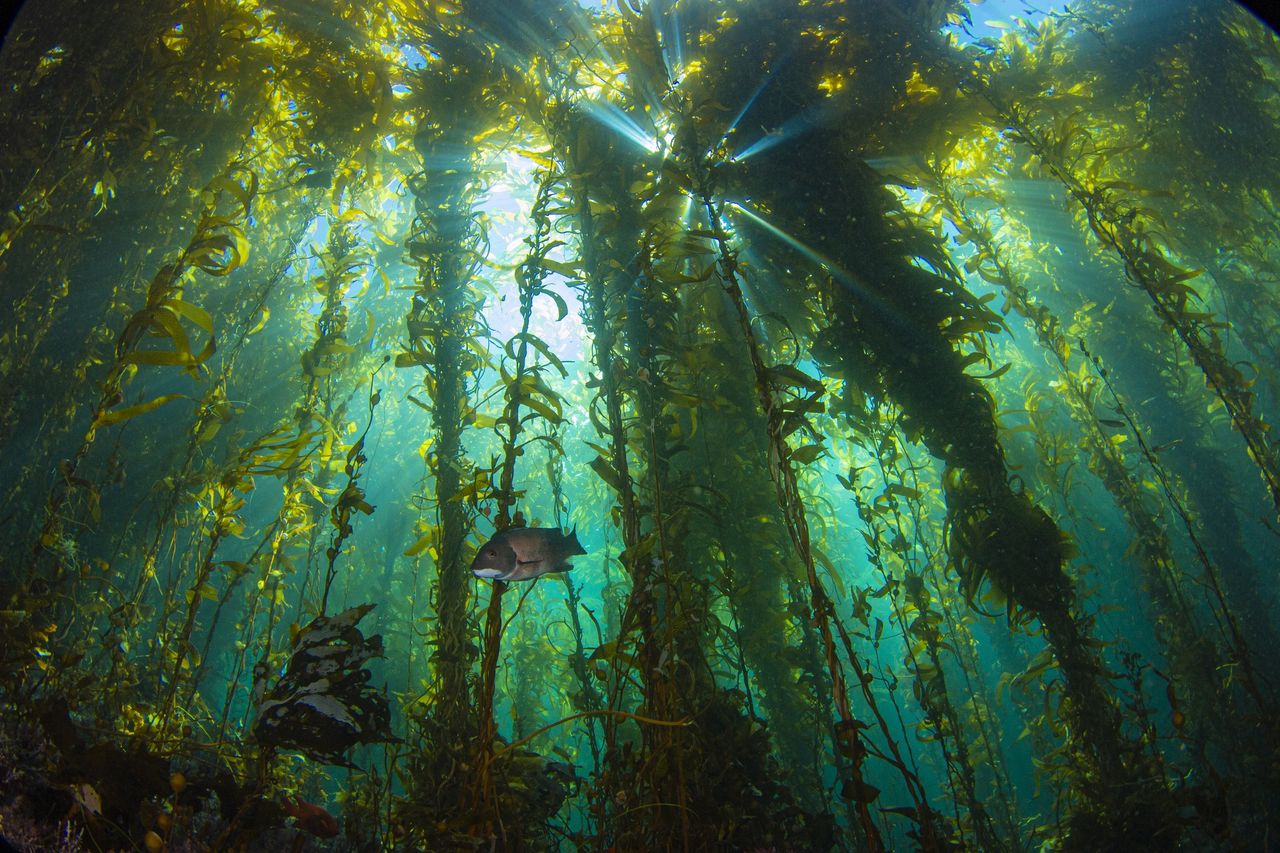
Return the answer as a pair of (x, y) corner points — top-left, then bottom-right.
(571, 117), (705, 844)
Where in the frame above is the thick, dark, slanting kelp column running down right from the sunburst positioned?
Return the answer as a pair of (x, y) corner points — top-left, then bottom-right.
(701, 0), (1160, 835)
